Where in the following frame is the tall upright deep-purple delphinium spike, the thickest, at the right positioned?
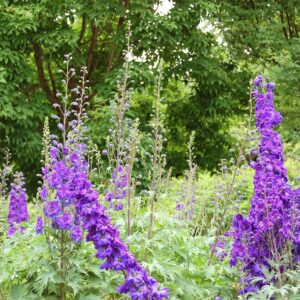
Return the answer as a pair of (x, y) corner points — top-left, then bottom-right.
(230, 75), (300, 293)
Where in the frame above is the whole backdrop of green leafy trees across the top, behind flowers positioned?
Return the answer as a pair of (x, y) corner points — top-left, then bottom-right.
(0, 0), (300, 192)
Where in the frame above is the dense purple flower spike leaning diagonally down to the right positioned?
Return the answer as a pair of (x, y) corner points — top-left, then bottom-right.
(72, 158), (168, 299)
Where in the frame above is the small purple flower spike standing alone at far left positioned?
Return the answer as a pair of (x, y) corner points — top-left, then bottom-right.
(7, 172), (29, 236)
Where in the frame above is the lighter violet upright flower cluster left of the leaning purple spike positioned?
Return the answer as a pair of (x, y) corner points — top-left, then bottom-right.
(36, 142), (87, 243)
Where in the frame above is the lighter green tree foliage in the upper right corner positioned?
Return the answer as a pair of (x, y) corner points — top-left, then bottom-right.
(207, 0), (300, 148)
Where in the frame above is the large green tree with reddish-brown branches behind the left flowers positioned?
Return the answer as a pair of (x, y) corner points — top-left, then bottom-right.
(0, 0), (251, 188)
